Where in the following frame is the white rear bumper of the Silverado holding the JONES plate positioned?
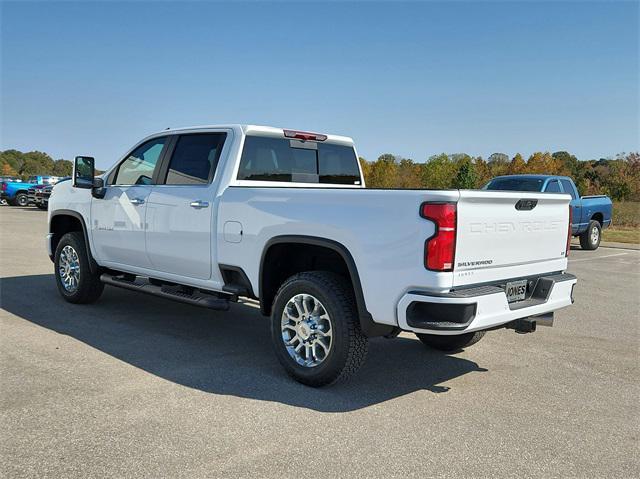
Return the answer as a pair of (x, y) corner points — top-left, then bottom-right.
(397, 273), (577, 335)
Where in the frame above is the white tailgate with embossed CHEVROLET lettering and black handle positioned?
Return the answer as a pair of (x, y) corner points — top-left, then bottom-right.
(453, 190), (571, 287)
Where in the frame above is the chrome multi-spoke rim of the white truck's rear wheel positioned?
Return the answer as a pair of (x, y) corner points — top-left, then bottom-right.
(281, 293), (332, 368)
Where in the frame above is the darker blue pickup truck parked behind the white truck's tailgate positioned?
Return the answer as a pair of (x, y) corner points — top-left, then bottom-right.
(482, 175), (612, 250)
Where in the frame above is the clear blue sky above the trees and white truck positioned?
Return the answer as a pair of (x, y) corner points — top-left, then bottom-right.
(0, 2), (640, 168)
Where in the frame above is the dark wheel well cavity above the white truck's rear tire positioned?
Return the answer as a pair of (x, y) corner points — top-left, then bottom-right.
(260, 243), (353, 315)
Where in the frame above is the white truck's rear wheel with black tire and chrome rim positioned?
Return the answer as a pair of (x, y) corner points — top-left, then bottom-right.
(271, 271), (368, 387)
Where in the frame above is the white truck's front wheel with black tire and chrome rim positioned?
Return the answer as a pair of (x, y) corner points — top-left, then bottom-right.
(54, 231), (104, 304)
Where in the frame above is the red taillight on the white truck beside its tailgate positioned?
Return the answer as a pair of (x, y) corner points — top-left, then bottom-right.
(420, 203), (456, 271)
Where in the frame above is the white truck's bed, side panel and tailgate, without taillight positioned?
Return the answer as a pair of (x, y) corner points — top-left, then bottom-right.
(217, 187), (569, 324)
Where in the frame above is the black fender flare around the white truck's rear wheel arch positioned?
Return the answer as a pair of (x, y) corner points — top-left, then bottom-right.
(258, 235), (394, 337)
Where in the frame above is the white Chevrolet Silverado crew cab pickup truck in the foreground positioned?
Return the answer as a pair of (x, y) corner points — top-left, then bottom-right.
(47, 125), (576, 386)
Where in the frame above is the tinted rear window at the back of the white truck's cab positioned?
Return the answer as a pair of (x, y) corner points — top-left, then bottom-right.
(238, 136), (360, 185)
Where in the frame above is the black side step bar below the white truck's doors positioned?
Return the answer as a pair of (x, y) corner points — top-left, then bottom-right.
(100, 273), (229, 311)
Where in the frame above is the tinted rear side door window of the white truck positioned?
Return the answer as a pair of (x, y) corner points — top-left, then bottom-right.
(165, 133), (227, 185)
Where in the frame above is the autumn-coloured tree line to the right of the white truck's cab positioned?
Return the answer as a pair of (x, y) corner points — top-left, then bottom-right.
(360, 151), (640, 201)
